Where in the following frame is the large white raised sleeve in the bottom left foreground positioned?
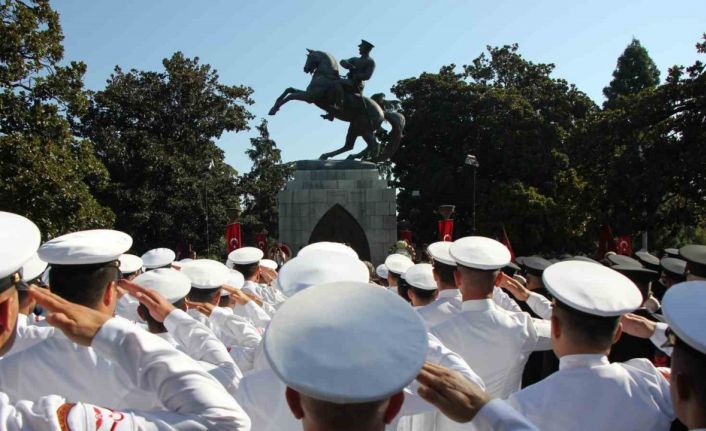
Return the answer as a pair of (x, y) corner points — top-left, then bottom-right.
(89, 319), (250, 431)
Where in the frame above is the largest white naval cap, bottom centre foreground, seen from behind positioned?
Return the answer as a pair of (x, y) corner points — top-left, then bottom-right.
(263, 282), (429, 404)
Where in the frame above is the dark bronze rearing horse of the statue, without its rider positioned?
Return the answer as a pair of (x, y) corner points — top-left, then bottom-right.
(270, 49), (405, 162)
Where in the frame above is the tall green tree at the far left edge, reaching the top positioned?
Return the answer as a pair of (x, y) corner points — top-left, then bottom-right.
(0, 0), (114, 237)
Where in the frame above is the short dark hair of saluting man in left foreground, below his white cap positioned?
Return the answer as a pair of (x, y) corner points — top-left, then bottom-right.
(49, 262), (120, 308)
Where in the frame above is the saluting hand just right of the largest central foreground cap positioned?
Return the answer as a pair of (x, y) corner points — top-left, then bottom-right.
(417, 362), (490, 422)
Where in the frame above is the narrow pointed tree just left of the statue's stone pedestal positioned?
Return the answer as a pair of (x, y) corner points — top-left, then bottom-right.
(239, 119), (293, 238)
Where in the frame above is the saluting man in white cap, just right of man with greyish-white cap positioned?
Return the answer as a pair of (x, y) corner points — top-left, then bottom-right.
(180, 259), (262, 372)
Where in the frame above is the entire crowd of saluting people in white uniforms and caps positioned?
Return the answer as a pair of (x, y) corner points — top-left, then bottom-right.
(0, 208), (706, 431)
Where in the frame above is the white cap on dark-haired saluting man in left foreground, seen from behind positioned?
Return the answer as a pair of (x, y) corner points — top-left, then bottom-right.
(38, 229), (132, 265)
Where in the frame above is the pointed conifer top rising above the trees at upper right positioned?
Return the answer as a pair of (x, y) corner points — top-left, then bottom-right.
(603, 38), (659, 107)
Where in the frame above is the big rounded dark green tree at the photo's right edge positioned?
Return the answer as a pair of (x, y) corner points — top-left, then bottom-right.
(570, 35), (706, 249)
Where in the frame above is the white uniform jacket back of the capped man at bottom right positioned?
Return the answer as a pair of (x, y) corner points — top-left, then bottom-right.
(508, 354), (675, 431)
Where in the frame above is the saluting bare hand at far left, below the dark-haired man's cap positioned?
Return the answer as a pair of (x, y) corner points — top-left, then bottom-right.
(28, 286), (111, 346)
